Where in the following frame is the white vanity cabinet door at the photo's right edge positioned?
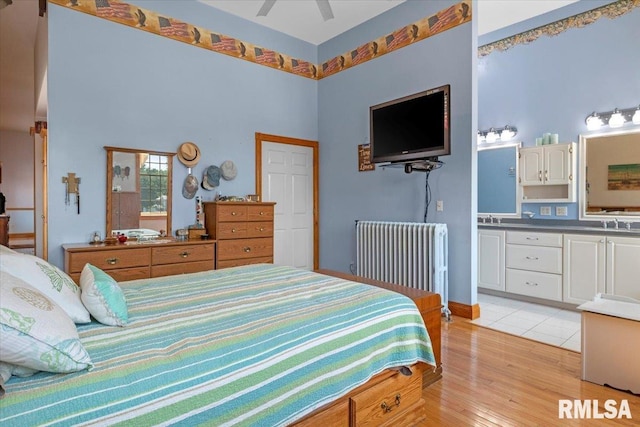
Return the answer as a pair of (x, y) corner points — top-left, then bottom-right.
(606, 237), (640, 299)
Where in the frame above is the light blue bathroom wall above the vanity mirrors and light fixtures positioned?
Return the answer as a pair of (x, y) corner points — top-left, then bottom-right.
(478, 1), (640, 220)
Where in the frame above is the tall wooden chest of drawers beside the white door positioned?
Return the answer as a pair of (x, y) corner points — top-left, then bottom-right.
(203, 202), (275, 268)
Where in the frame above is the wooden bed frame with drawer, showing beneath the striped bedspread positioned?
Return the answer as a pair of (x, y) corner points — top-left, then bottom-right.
(293, 270), (442, 427)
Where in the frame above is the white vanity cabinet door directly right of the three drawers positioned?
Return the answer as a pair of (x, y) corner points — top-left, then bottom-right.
(562, 234), (606, 304)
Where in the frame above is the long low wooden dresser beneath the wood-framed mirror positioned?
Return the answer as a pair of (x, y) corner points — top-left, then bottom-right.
(62, 240), (215, 283)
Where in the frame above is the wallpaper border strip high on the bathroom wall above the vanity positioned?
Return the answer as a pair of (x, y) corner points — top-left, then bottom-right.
(478, 0), (640, 57)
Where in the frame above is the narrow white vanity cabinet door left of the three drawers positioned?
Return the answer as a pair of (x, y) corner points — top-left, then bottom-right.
(478, 230), (505, 291)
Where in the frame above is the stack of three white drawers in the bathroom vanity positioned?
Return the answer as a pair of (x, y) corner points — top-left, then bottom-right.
(505, 231), (562, 301)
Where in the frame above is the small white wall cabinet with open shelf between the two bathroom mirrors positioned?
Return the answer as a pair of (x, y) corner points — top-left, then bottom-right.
(519, 143), (576, 202)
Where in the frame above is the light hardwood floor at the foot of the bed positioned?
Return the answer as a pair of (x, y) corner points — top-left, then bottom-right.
(422, 317), (640, 427)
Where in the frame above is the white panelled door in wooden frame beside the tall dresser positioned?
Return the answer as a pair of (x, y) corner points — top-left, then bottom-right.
(261, 142), (314, 270)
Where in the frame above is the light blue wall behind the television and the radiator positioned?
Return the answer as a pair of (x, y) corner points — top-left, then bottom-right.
(318, 1), (476, 304)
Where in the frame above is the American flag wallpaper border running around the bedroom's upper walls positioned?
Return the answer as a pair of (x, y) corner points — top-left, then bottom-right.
(49, 0), (470, 80)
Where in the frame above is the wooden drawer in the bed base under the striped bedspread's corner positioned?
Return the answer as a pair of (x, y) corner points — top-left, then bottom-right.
(351, 367), (422, 426)
